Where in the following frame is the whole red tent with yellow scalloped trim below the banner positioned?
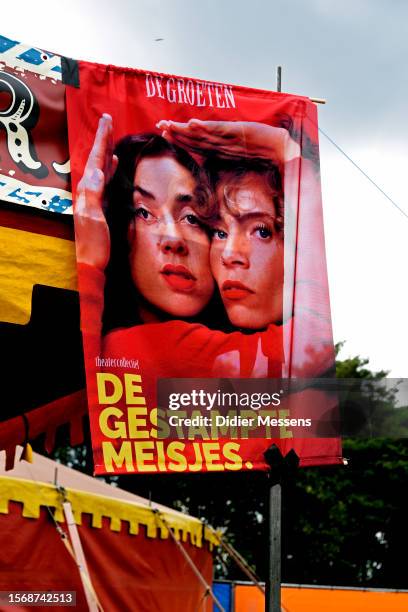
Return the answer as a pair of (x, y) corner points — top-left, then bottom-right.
(0, 447), (218, 612)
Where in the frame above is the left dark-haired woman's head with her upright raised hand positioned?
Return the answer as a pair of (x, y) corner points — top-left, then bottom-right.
(76, 116), (214, 331)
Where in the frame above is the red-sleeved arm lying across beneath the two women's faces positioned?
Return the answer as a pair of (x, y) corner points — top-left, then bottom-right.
(104, 321), (283, 378)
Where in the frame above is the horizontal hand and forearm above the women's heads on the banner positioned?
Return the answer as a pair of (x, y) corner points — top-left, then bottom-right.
(157, 119), (300, 164)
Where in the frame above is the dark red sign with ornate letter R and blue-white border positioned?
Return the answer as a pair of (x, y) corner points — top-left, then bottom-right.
(0, 36), (72, 214)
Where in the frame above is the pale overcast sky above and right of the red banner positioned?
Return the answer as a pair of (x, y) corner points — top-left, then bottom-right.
(0, 0), (408, 377)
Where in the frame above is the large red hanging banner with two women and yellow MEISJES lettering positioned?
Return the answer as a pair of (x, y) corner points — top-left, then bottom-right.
(66, 62), (342, 474)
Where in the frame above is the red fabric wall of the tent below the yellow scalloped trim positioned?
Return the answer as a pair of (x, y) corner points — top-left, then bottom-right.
(0, 502), (212, 612)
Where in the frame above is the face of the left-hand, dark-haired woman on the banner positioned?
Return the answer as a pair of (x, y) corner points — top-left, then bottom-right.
(129, 156), (214, 317)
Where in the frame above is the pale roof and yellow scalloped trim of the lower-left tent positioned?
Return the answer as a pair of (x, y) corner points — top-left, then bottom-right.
(0, 448), (219, 548)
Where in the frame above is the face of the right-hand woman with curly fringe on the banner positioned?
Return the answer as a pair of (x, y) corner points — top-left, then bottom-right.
(211, 172), (283, 329)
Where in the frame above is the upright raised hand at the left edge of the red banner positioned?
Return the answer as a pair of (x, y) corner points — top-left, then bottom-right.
(74, 114), (118, 272)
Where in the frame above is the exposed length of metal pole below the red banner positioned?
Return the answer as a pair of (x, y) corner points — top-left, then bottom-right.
(265, 482), (282, 612)
